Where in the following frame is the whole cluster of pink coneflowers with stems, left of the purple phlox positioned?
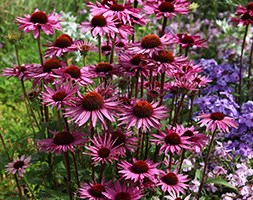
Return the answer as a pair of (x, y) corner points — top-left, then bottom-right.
(2, 0), (241, 200)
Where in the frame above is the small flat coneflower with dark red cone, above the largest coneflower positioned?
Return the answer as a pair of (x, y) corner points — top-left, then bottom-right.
(89, 62), (117, 78)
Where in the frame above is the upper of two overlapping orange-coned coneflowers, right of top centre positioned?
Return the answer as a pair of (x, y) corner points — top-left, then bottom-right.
(129, 34), (176, 57)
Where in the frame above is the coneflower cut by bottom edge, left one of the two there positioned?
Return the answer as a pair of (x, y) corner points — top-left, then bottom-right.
(78, 180), (111, 200)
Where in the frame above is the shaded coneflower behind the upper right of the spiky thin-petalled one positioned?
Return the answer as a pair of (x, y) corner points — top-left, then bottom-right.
(108, 129), (138, 154)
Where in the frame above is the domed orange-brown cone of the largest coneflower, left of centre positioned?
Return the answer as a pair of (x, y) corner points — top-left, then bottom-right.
(82, 92), (104, 111)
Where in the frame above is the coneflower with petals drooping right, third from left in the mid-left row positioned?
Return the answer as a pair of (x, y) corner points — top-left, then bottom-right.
(54, 65), (93, 86)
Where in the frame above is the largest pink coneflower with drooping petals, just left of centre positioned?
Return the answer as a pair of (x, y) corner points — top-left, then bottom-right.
(65, 91), (118, 128)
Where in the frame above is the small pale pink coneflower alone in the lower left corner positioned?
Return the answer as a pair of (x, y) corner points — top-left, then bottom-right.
(5, 155), (31, 177)
